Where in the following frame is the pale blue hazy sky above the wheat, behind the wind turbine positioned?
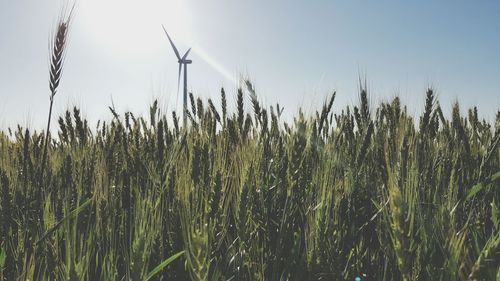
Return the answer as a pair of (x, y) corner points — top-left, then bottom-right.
(0, 0), (500, 130)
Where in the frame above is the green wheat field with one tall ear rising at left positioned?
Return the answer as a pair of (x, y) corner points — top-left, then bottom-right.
(0, 6), (500, 281)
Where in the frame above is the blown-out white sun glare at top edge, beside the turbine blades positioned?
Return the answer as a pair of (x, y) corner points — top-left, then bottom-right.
(79, 0), (194, 57)
